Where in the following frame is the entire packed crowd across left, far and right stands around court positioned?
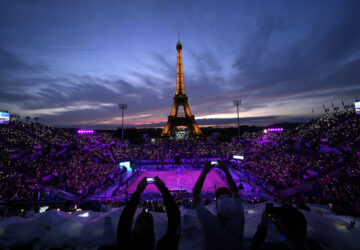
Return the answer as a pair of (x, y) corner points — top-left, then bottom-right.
(0, 113), (360, 213)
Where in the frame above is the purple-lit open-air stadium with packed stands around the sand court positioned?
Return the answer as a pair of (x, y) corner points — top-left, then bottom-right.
(0, 110), (360, 249)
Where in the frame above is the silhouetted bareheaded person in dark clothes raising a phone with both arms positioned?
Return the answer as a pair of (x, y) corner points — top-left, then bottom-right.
(117, 177), (181, 250)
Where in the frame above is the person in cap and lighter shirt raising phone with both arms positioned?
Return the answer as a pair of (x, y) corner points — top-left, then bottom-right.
(193, 162), (245, 250)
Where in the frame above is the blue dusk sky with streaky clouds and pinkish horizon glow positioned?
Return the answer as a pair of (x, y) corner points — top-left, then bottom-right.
(0, 0), (360, 127)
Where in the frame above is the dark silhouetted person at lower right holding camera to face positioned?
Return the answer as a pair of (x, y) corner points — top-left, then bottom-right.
(251, 204), (322, 250)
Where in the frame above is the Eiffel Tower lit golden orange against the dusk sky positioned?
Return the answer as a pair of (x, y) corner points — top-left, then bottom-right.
(161, 37), (203, 136)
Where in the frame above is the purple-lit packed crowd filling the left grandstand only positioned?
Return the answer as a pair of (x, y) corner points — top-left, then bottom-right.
(0, 123), (124, 201)
